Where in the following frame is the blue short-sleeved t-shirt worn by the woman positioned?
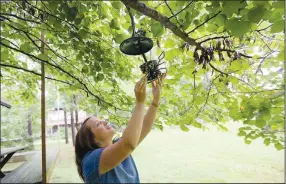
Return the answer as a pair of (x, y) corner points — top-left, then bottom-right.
(82, 139), (140, 183)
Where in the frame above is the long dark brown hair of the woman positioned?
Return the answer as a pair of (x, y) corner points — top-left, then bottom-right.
(75, 117), (99, 181)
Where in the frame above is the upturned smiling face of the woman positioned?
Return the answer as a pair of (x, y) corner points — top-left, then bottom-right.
(86, 117), (115, 142)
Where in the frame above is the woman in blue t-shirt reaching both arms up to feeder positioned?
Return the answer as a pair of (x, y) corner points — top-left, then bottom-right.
(75, 75), (166, 183)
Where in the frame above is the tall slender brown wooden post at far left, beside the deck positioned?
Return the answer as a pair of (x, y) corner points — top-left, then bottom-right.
(41, 31), (47, 183)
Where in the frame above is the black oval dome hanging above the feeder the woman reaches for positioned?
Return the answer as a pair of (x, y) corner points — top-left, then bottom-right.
(120, 36), (153, 55)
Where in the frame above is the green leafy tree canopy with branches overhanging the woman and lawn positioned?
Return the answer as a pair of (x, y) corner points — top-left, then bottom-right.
(0, 0), (285, 150)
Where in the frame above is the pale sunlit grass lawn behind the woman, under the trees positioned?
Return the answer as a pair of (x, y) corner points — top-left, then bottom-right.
(50, 123), (284, 183)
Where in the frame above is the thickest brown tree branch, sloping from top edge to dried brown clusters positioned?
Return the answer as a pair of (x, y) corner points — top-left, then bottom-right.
(121, 0), (202, 49)
